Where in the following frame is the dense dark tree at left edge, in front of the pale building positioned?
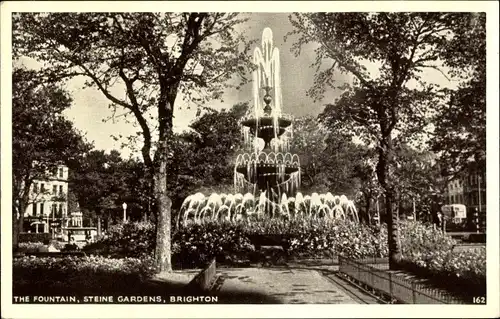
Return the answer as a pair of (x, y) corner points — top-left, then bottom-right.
(12, 68), (89, 247)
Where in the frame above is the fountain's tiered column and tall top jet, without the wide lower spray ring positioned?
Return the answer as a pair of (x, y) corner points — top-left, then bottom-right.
(234, 28), (300, 202)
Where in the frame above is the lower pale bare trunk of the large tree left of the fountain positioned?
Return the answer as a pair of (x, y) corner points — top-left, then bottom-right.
(154, 141), (172, 273)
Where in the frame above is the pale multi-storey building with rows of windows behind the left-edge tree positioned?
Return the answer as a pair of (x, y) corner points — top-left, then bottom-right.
(24, 165), (69, 234)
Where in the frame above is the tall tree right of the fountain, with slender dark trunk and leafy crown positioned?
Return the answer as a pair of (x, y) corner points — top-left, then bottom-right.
(290, 12), (471, 268)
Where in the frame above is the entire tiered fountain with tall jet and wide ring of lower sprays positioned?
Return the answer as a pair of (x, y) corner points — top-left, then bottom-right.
(179, 28), (359, 224)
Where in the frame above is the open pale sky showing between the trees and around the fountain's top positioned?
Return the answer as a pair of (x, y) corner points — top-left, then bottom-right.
(47, 13), (346, 157)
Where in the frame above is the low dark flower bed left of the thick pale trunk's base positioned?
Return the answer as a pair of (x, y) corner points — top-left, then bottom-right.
(13, 256), (153, 295)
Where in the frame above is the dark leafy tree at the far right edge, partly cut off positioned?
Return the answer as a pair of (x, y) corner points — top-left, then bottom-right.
(431, 13), (486, 179)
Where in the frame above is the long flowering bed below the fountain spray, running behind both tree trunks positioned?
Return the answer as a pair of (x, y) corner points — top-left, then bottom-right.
(80, 219), (486, 296)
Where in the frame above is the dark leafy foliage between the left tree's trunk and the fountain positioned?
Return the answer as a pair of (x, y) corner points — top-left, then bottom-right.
(168, 103), (248, 208)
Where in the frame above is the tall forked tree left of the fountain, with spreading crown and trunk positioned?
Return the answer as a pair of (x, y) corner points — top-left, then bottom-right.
(13, 12), (250, 272)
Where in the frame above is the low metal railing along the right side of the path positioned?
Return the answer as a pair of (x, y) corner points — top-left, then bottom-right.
(339, 256), (464, 304)
